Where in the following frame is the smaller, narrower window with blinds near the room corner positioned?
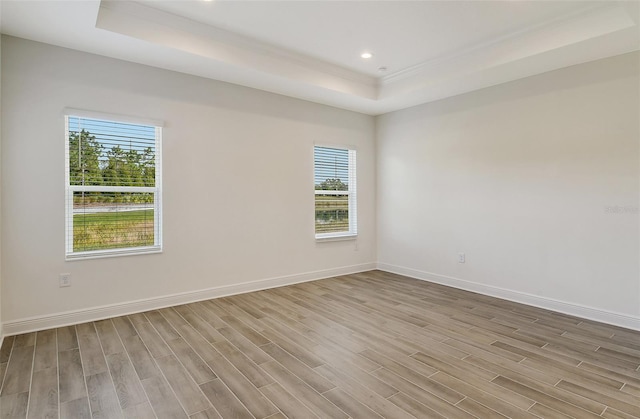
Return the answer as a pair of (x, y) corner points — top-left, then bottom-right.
(313, 146), (358, 239)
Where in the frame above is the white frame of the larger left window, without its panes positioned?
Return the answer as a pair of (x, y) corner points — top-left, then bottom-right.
(64, 108), (164, 261)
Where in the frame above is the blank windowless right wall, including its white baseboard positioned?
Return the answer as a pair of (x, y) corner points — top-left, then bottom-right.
(377, 53), (640, 328)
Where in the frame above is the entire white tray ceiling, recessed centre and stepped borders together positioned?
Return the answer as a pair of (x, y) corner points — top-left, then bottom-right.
(0, 0), (640, 115)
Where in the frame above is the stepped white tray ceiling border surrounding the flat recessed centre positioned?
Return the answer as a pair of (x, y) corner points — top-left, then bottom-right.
(0, 0), (640, 115)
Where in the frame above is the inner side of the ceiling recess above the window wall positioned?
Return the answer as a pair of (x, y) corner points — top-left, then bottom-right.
(96, 0), (378, 99)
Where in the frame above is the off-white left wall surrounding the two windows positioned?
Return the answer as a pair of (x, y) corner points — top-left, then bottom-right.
(1, 37), (376, 332)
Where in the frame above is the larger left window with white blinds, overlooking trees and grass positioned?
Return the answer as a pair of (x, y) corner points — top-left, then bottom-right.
(65, 111), (162, 259)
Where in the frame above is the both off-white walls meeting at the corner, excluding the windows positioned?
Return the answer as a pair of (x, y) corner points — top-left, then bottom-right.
(5, 37), (640, 333)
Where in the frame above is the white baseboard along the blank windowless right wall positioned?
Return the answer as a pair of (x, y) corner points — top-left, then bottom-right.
(378, 263), (640, 331)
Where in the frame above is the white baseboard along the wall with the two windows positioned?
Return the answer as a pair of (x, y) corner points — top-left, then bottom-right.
(0, 263), (376, 337)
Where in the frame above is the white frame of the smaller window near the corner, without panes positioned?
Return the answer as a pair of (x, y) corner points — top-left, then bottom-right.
(312, 143), (358, 242)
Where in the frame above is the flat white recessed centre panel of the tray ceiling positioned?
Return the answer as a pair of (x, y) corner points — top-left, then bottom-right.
(138, 1), (589, 77)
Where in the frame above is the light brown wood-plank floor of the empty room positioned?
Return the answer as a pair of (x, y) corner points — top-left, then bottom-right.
(0, 271), (640, 419)
